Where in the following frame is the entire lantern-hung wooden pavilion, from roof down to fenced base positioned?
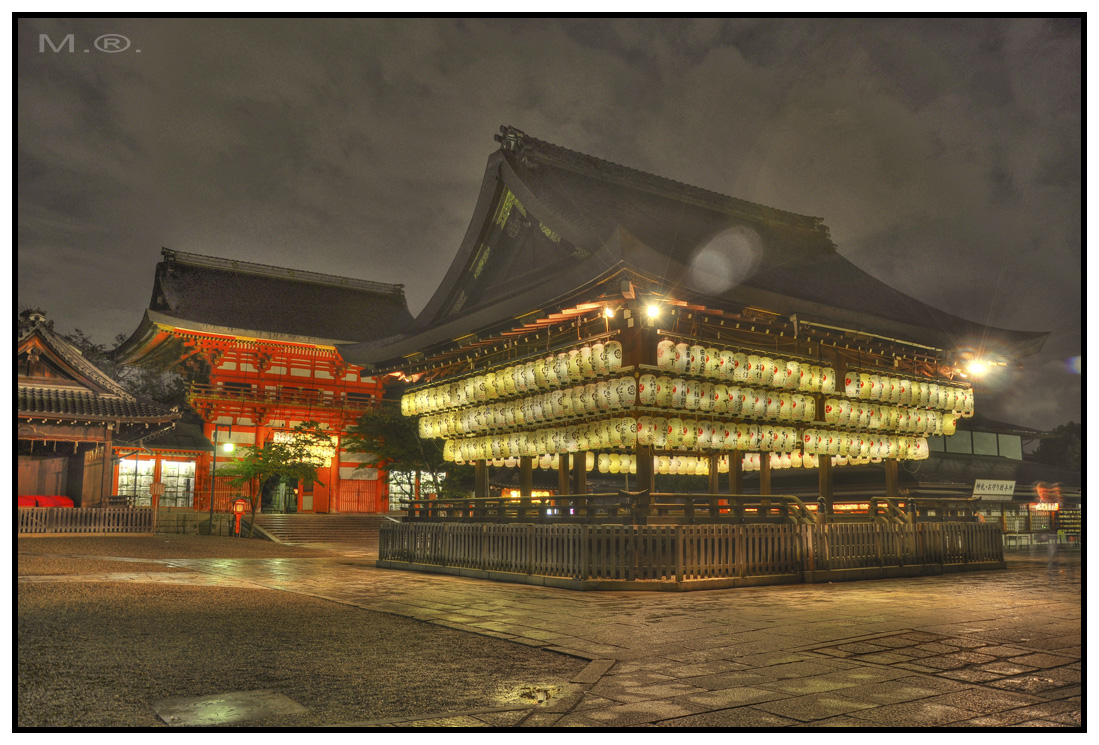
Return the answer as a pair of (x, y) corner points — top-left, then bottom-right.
(340, 126), (1048, 590)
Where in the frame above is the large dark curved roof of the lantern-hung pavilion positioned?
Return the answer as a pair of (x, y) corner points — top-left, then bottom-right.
(341, 126), (1048, 364)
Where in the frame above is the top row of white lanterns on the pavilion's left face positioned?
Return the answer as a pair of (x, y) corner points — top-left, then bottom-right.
(401, 341), (622, 416)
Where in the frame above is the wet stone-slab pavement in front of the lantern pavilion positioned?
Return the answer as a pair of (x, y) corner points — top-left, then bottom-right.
(98, 548), (1084, 729)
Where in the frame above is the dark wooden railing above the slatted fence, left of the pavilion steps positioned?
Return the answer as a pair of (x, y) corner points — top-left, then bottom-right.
(406, 491), (815, 525)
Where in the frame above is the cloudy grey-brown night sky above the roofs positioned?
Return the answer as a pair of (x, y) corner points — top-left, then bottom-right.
(16, 19), (1083, 429)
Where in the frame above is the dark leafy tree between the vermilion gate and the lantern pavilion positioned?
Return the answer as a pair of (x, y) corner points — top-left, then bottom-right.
(343, 400), (473, 507)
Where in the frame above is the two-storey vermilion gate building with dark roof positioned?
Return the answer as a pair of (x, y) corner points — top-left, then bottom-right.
(115, 248), (412, 512)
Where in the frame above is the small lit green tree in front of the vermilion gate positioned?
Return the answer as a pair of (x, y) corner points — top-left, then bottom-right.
(218, 422), (332, 538)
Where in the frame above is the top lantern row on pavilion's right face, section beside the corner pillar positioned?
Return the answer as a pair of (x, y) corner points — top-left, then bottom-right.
(656, 340), (835, 393)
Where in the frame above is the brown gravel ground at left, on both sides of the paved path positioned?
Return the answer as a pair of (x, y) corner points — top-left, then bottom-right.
(16, 536), (585, 729)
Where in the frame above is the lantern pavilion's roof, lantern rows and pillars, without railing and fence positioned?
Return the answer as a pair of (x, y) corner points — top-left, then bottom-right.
(340, 127), (1048, 502)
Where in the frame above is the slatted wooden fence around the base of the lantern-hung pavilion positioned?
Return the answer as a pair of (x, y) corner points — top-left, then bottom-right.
(378, 522), (1003, 585)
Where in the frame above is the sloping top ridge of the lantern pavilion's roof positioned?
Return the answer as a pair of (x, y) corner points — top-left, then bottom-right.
(495, 125), (830, 235)
